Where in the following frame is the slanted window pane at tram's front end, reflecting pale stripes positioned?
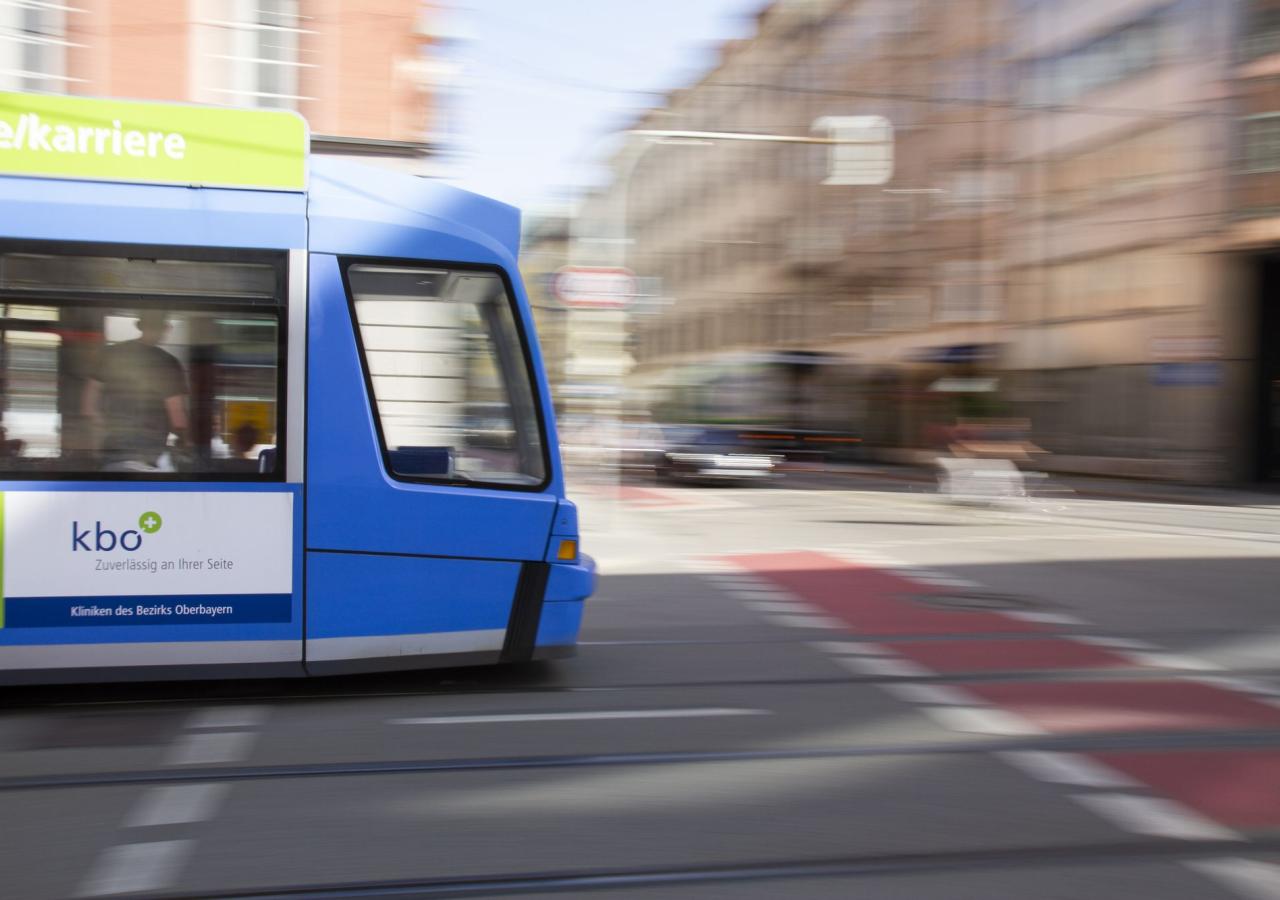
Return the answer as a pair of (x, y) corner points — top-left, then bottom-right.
(347, 264), (547, 486)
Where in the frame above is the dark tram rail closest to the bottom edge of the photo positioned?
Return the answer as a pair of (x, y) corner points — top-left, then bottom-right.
(129, 837), (1280, 900)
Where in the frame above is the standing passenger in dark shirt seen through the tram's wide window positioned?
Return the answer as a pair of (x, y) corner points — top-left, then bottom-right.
(83, 310), (187, 469)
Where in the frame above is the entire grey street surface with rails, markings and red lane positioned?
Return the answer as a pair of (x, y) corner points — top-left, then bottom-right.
(0, 475), (1280, 900)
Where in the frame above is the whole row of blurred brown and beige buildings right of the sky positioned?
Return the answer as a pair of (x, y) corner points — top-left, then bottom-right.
(582, 0), (1280, 481)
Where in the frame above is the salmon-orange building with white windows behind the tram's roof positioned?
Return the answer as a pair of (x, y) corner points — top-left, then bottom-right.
(0, 0), (442, 170)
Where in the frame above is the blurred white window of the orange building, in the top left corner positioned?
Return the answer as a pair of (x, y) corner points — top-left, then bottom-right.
(0, 0), (69, 91)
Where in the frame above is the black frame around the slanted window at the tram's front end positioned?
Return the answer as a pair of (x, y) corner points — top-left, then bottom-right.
(338, 256), (554, 493)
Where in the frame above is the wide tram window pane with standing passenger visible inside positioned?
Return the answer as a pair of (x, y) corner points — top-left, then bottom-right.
(0, 252), (282, 480)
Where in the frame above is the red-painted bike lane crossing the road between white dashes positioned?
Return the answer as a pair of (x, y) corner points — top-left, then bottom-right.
(721, 550), (1280, 832)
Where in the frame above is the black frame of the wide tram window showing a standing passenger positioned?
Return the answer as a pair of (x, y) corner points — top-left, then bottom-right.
(0, 238), (289, 484)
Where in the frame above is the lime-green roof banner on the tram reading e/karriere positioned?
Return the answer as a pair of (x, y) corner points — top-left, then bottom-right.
(0, 92), (308, 191)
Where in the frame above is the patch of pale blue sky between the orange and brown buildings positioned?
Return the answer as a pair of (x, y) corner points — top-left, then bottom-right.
(449, 0), (765, 215)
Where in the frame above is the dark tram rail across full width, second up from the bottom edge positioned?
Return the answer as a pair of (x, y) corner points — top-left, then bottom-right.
(0, 728), (1280, 794)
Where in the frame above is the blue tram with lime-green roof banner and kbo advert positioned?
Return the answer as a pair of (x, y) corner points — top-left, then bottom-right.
(0, 93), (595, 684)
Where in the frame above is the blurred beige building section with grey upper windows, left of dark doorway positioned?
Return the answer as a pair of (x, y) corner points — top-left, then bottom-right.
(1004, 0), (1247, 480)
